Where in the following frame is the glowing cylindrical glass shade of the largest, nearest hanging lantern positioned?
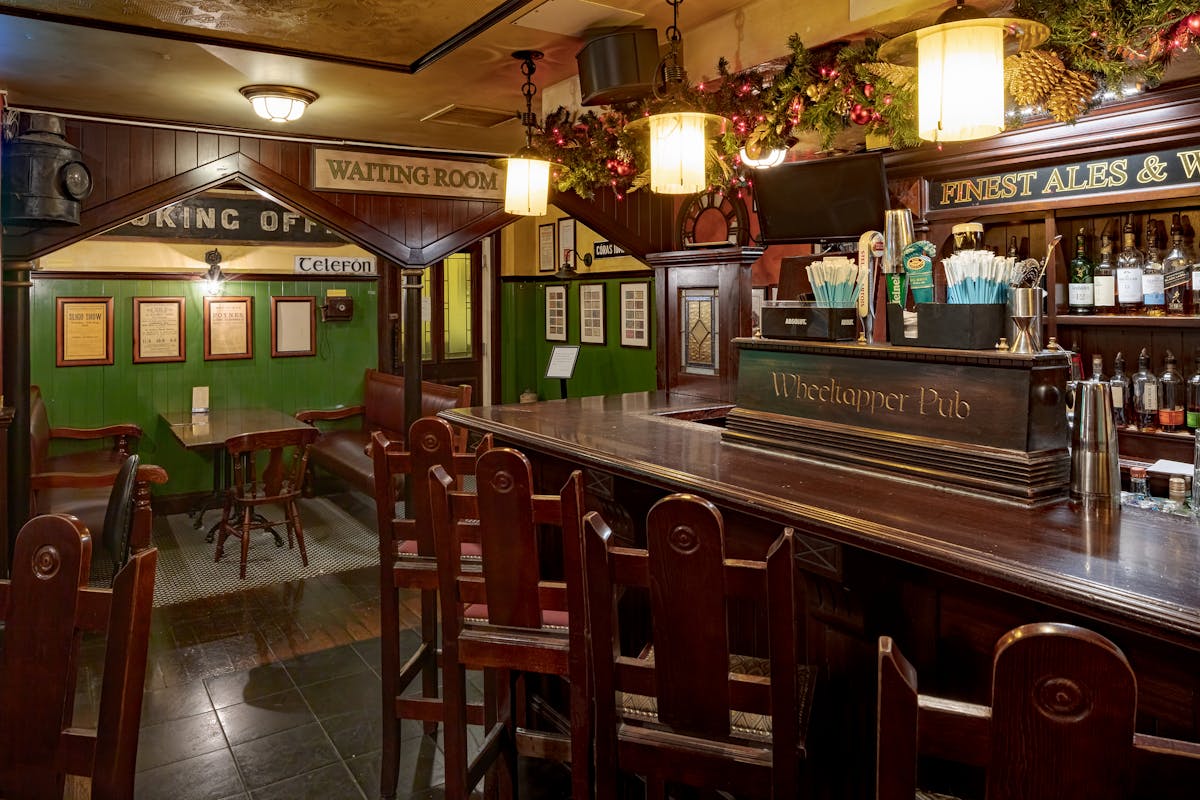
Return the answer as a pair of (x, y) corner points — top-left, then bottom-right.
(917, 19), (1004, 142)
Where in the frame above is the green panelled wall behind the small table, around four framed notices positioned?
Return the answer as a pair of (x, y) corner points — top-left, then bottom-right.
(30, 273), (379, 494)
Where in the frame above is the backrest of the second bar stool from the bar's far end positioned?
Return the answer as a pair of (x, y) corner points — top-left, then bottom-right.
(430, 447), (583, 633)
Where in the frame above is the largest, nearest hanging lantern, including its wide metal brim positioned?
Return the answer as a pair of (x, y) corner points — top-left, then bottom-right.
(880, 0), (1050, 142)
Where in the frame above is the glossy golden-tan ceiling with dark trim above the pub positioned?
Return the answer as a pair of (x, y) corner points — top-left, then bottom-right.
(0, 0), (964, 154)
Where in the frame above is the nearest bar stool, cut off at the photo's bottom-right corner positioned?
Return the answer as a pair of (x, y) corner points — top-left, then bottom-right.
(876, 622), (1200, 800)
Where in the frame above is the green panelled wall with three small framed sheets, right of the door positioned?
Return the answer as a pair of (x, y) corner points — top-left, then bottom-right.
(500, 277), (658, 403)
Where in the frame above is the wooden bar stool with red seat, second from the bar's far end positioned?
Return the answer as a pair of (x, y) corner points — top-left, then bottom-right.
(430, 447), (592, 800)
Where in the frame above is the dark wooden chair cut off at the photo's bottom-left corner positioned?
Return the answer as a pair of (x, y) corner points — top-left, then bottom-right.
(0, 515), (158, 800)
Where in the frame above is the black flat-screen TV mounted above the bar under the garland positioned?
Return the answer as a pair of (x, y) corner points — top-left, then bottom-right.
(752, 152), (888, 245)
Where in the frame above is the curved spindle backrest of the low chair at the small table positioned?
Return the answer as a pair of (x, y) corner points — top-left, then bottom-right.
(226, 426), (320, 499)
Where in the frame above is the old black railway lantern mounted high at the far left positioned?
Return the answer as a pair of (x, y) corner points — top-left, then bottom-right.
(0, 113), (91, 227)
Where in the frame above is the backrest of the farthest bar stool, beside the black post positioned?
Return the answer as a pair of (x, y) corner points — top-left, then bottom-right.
(371, 416), (492, 564)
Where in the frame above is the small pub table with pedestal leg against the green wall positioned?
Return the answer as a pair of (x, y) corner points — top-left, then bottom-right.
(160, 408), (308, 545)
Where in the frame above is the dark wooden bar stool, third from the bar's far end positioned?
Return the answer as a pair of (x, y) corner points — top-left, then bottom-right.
(583, 494), (815, 800)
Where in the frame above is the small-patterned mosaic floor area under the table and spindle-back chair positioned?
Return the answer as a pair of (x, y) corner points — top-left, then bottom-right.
(154, 493), (379, 607)
